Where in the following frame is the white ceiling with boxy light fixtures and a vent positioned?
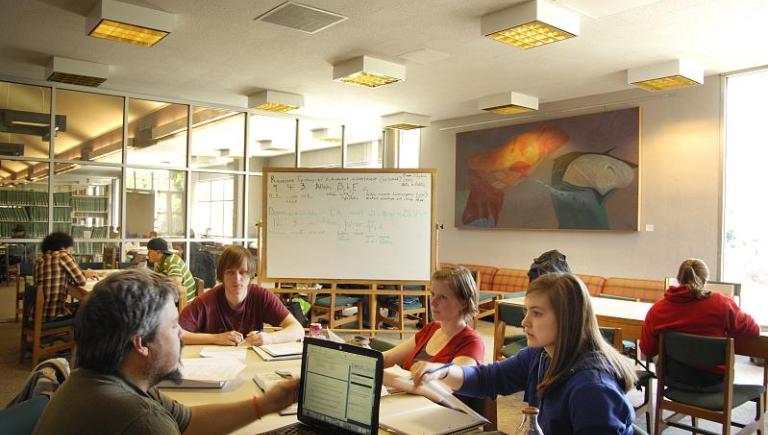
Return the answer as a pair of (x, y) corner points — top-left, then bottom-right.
(0, 0), (768, 121)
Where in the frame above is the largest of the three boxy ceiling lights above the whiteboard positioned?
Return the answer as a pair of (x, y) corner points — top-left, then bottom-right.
(333, 56), (405, 88)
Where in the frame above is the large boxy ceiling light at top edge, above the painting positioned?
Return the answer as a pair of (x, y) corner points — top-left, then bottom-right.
(480, 0), (580, 49)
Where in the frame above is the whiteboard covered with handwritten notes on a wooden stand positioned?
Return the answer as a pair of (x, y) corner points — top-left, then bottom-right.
(261, 168), (434, 281)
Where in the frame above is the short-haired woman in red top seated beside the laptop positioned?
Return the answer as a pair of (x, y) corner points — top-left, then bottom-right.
(384, 266), (485, 370)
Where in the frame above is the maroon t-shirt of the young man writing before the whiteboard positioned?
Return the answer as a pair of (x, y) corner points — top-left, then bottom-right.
(179, 284), (288, 335)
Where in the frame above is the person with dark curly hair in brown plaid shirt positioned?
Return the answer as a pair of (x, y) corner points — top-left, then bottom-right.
(34, 232), (98, 322)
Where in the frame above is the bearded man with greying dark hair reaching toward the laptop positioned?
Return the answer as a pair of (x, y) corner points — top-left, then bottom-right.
(34, 270), (298, 435)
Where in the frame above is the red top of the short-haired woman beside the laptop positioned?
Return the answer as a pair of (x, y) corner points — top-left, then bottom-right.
(403, 322), (485, 370)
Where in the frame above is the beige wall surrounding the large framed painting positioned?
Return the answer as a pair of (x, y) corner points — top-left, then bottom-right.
(422, 76), (722, 279)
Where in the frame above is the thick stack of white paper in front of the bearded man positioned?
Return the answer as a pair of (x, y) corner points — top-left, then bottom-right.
(158, 357), (245, 388)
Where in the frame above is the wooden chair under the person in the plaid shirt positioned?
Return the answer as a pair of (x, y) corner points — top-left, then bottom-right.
(19, 285), (75, 366)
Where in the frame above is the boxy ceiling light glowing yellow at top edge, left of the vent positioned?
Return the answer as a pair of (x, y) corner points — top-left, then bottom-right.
(85, 0), (174, 47)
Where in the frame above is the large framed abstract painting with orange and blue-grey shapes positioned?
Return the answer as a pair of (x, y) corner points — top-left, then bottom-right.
(455, 107), (640, 231)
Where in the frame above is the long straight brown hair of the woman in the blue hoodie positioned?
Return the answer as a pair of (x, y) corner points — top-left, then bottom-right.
(526, 273), (637, 397)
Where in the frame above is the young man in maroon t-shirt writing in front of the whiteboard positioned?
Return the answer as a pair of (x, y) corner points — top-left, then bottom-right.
(179, 245), (304, 346)
